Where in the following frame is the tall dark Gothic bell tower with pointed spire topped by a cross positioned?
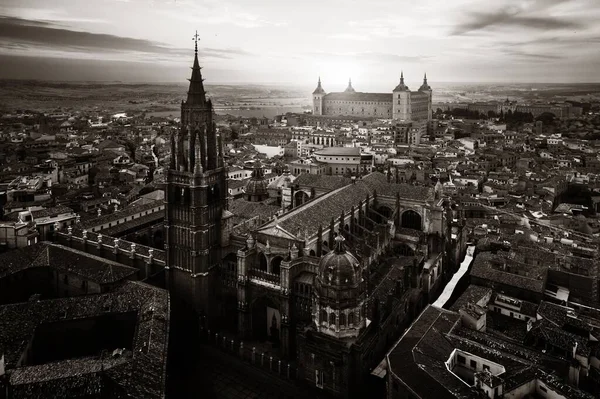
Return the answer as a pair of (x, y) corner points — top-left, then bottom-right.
(165, 34), (228, 323)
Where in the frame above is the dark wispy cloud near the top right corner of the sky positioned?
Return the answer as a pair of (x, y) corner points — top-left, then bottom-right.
(451, 8), (583, 35)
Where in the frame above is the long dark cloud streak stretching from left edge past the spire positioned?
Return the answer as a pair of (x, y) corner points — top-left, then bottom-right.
(0, 16), (250, 59)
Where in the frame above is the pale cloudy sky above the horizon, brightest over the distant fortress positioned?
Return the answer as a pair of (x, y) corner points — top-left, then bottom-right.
(0, 0), (600, 91)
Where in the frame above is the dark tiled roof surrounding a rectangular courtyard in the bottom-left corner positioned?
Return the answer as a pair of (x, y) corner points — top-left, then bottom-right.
(0, 282), (169, 398)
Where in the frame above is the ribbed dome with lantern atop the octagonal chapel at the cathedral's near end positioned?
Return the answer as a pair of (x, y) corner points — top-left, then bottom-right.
(319, 235), (362, 289)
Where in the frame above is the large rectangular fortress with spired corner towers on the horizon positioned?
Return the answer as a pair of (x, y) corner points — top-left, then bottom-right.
(313, 73), (433, 122)
